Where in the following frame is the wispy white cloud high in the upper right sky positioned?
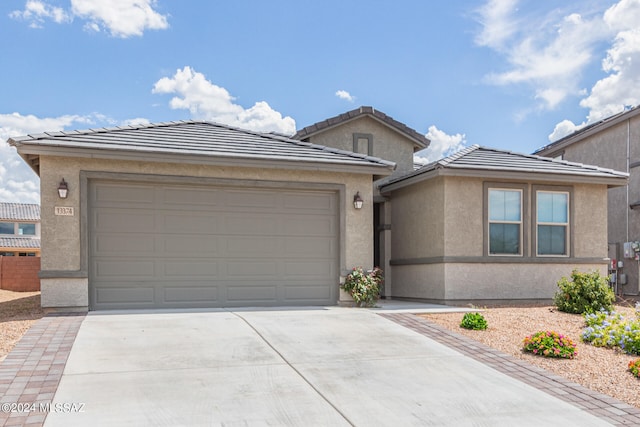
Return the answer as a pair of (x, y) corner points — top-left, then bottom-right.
(476, 0), (611, 109)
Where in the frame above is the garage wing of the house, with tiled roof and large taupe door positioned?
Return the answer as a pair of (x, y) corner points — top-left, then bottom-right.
(9, 121), (395, 310)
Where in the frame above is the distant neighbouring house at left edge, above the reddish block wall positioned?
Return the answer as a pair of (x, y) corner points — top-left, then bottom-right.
(0, 202), (40, 257)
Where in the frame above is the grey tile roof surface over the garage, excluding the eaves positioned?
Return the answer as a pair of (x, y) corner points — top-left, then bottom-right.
(8, 121), (395, 171)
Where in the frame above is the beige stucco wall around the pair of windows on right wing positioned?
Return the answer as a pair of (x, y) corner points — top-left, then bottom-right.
(390, 177), (607, 303)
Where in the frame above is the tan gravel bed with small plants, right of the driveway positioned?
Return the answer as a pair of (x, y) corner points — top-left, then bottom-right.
(421, 304), (640, 408)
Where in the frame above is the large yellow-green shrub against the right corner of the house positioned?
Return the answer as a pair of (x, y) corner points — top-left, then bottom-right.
(553, 270), (616, 314)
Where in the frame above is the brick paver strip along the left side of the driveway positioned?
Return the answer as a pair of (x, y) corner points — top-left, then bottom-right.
(0, 313), (86, 427)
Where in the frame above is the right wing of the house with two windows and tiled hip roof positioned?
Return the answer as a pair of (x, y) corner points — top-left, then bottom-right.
(380, 145), (626, 304)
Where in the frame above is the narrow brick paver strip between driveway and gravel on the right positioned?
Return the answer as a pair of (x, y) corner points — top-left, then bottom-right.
(380, 313), (640, 426)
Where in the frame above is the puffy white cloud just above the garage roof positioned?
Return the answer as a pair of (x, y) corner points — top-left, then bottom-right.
(152, 66), (296, 135)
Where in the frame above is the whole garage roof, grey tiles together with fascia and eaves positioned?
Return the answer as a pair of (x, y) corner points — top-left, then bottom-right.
(8, 121), (395, 175)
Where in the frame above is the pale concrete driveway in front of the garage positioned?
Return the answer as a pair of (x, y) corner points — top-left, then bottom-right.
(45, 307), (609, 427)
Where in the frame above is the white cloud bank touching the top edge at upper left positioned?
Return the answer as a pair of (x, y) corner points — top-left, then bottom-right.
(9, 0), (169, 38)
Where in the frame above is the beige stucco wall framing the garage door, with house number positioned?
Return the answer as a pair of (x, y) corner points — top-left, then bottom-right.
(40, 156), (373, 307)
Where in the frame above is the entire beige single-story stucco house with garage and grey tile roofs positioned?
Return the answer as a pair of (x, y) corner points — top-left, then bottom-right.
(9, 107), (627, 310)
